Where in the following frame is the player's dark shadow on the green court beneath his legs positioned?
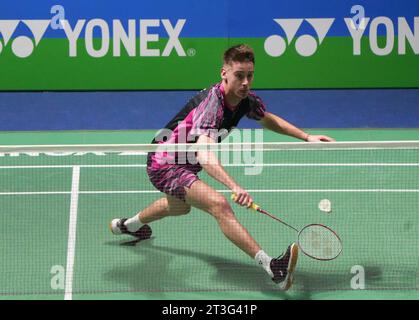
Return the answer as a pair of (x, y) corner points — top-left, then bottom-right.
(104, 237), (404, 300)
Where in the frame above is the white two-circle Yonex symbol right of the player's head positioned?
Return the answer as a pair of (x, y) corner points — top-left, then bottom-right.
(265, 18), (335, 57)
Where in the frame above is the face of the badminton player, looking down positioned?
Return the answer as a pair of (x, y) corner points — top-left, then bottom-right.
(221, 62), (255, 99)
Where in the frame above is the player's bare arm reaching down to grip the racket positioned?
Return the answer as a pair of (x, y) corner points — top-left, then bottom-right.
(196, 135), (253, 206)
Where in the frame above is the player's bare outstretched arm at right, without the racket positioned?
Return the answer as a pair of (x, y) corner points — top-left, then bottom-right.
(259, 111), (335, 142)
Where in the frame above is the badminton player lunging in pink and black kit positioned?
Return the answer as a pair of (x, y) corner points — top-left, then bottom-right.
(110, 45), (333, 290)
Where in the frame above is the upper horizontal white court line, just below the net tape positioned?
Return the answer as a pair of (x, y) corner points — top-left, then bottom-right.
(0, 163), (419, 169)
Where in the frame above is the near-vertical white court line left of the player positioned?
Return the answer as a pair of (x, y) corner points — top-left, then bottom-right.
(64, 166), (80, 300)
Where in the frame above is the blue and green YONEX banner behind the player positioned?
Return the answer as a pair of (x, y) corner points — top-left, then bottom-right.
(0, 0), (419, 91)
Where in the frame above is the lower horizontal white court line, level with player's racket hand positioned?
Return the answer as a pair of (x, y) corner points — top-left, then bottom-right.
(0, 189), (419, 196)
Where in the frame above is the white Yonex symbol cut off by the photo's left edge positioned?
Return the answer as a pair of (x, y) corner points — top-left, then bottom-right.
(0, 20), (51, 58)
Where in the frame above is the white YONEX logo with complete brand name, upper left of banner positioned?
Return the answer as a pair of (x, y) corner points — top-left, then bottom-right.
(0, 18), (187, 58)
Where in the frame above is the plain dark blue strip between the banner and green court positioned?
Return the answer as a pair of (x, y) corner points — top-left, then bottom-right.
(0, 89), (419, 131)
